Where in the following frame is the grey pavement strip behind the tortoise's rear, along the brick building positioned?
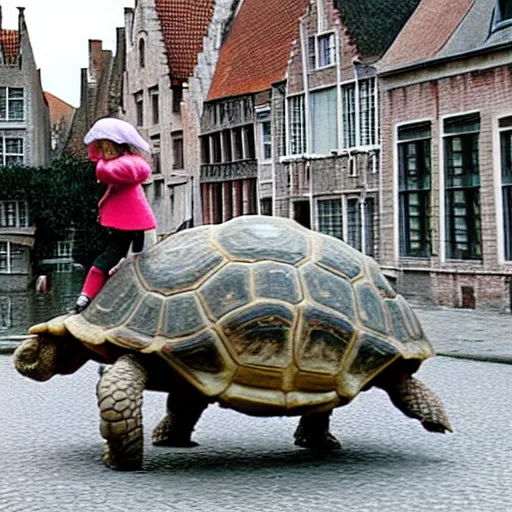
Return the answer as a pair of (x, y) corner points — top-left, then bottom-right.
(415, 308), (512, 364)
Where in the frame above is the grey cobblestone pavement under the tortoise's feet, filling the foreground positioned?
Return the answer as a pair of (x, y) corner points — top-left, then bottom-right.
(0, 356), (512, 512)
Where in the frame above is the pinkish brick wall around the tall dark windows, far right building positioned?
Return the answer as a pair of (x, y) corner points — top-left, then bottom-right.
(380, 48), (512, 310)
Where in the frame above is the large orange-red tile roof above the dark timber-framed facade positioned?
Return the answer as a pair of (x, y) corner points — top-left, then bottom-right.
(208, 0), (309, 100)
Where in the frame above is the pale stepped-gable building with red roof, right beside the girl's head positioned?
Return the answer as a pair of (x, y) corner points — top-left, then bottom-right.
(122, 0), (221, 235)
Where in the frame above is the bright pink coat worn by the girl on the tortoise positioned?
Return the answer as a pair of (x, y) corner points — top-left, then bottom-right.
(96, 155), (156, 231)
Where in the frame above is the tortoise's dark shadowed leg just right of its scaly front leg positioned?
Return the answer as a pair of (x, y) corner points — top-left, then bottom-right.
(152, 390), (208, 448)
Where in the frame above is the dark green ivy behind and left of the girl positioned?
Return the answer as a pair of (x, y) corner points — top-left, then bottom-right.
(0, 157), (106, 267)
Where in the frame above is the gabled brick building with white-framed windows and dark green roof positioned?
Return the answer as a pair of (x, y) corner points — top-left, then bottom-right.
(272, 0), (419, 256)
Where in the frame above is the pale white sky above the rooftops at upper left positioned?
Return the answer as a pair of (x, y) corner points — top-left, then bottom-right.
(0, 0), (130, 107)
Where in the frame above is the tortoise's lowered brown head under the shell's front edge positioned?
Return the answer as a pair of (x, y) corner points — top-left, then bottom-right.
(13, 333), (88, 382)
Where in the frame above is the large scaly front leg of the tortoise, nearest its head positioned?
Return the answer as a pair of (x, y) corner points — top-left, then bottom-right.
(97, 354), (147, 470)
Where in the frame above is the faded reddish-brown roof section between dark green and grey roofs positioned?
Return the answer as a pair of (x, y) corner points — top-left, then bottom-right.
(379, 0), (475, 71)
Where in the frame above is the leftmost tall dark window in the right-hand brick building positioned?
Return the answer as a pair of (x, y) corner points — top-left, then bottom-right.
(398, 122), (432, 257)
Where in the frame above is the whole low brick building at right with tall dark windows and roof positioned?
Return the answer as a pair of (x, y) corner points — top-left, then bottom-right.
(379, 0), (512, 311)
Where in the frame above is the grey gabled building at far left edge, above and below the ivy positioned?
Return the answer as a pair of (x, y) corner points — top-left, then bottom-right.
(0, 7), (50, 290)
